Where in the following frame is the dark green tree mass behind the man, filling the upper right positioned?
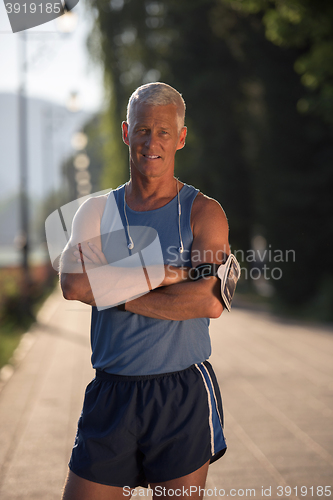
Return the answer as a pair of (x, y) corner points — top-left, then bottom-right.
(86, 0), (333, 320)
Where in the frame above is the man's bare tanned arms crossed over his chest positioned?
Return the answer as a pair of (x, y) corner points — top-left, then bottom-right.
(60, 194), (230, 320)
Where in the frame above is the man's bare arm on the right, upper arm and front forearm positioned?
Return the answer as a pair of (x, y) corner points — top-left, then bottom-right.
(125, 195), (230, 321)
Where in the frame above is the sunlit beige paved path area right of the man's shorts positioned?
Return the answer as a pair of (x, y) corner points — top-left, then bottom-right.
(207, 309), (333, 498)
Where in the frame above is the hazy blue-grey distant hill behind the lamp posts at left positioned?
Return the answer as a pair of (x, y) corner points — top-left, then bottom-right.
(0, 93), (92, 267)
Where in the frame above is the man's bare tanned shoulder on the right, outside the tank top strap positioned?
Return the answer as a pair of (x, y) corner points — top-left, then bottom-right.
(191, 192), (228, 235)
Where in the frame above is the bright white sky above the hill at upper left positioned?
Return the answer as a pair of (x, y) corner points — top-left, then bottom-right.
(0, 0), (103, 113)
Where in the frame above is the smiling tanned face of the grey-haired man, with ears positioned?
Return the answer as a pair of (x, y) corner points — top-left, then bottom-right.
(123, 103), (186, 178)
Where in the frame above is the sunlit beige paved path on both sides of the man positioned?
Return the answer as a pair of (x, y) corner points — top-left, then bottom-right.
(0, 291), (333, 500)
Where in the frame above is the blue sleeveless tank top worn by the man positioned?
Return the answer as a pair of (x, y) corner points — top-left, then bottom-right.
(91, 184), (211, 375)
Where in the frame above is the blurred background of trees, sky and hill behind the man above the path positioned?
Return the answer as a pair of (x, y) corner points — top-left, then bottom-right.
(0, 0), (333, 366)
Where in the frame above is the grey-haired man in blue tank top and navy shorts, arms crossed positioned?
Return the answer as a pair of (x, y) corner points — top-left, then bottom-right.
(61, 83), (230, 500)
